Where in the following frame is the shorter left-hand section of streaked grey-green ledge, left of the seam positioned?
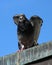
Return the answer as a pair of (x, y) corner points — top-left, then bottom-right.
(0, 53), (18, 65)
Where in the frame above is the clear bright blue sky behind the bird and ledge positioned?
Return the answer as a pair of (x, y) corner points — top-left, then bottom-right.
(0, 0), (52, 56)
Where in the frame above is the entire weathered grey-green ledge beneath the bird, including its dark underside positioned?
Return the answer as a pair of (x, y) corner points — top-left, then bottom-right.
(0, 42), (52, 65)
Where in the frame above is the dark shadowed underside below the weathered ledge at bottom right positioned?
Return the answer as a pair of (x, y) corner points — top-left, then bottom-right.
(25, 56), (52, 65)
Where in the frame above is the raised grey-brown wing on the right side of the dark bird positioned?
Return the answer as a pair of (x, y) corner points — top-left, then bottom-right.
(30, 16), (43, 42)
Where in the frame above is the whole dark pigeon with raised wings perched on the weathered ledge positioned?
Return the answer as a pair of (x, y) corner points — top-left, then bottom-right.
(13, 14), (43, 51)
